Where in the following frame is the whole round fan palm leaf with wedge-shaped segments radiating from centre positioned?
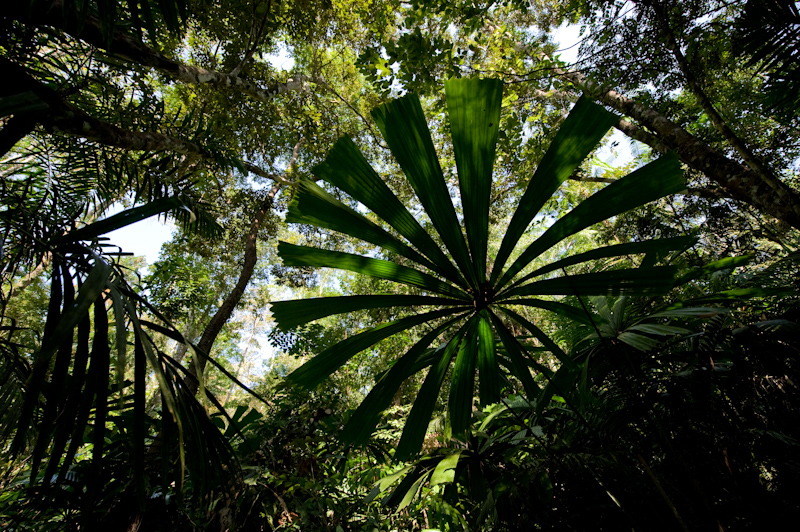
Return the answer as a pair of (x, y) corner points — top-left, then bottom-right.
(272, 79), (689, 456)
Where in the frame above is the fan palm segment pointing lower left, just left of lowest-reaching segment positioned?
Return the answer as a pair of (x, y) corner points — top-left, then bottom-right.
(339, 316), (462, 444)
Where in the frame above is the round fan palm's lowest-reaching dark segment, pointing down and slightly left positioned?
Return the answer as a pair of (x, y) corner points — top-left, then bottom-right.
(394, 325), (466, 460)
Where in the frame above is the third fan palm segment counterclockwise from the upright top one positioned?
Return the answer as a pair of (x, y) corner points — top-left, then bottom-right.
(286, 180), (440, 281)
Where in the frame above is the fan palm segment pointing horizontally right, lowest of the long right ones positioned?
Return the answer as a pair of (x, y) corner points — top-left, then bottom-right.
(503, 266), (676, 297)
